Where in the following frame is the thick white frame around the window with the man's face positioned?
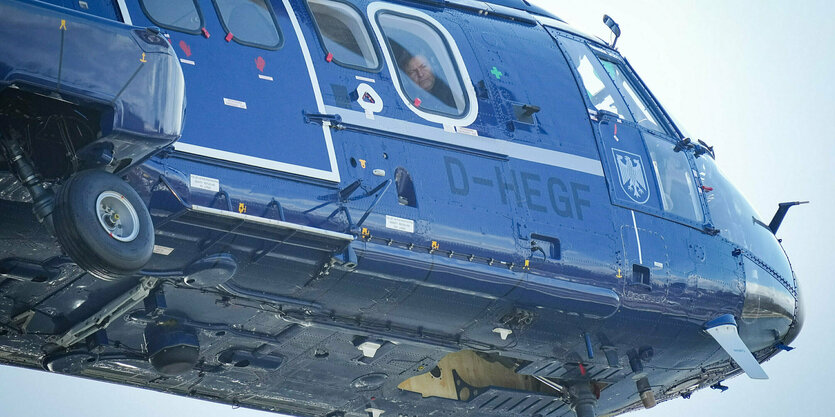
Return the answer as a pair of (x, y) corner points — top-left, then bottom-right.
(367, 2), (478, 126)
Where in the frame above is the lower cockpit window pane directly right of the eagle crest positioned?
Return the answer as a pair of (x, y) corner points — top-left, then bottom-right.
(644, 134), (704, 223)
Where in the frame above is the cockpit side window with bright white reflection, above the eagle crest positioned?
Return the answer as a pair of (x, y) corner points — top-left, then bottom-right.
(562, 38), (632, 121)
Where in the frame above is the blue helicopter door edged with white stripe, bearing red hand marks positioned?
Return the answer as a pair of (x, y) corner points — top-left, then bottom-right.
(131, 0), (339, 182)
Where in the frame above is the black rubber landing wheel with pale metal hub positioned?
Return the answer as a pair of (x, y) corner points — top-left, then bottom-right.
(53, 170), (154, 281)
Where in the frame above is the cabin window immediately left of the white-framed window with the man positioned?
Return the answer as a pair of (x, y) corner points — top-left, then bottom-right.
(307, 0), (379, 70)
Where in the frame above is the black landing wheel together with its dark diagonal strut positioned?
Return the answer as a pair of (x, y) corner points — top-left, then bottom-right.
(0, 124), (154, 281)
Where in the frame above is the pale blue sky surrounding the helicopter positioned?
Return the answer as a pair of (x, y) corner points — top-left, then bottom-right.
(0, 0), (835, 417)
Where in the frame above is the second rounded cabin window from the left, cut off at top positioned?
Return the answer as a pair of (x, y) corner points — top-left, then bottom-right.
(214, 0), (282, 49)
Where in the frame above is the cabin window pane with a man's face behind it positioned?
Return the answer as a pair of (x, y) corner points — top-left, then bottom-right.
(377, 12), (469, 118)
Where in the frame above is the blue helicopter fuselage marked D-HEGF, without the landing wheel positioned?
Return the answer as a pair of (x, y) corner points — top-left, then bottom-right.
(0, 0), (802, 417)
